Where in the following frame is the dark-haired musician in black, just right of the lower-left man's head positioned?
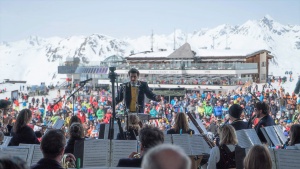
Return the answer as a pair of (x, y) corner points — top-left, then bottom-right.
(65, 122), (84, 154)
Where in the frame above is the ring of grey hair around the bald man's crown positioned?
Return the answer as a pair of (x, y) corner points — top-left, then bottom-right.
(142, 144), (191, 169)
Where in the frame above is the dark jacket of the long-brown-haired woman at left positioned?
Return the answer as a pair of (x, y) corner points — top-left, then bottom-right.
(8, 125), (40, 146)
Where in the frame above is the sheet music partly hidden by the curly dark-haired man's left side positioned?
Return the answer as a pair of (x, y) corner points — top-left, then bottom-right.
(111, 140), (138, 166)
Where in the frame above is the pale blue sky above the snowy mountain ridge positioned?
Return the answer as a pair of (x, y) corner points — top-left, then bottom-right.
(0, 0), (300, 41)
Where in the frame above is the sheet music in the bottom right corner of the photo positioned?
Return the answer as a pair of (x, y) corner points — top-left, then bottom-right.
(274, 149), (300, 169)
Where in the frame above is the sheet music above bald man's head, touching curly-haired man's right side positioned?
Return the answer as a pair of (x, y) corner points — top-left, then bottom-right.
(172, 134), (192, 155)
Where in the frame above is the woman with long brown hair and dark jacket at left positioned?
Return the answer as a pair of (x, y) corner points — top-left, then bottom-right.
(8, 109), (40, 146)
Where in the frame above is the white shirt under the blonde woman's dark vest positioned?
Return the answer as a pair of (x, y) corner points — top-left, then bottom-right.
(207, 144), (235, 169)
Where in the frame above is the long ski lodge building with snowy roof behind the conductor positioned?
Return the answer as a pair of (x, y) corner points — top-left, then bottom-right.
(58, 43), (273, 91)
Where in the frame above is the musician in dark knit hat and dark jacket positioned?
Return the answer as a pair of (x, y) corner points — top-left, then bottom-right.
(229, 104), (248, 131)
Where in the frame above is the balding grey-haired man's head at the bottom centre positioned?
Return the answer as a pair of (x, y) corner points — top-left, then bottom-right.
(142, 144), (191, 169)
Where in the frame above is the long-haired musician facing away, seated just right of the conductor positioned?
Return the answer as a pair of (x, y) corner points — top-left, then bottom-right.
(167, 113), (195, 134)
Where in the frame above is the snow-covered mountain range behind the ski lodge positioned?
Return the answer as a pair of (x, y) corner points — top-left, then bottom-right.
(0, 15), (300, 84)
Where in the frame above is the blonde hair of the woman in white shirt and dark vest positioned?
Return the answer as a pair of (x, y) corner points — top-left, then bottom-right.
(219, 125), (238, 145)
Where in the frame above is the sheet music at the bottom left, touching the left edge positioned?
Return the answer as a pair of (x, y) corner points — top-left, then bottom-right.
(0, 146), (29, 162)
